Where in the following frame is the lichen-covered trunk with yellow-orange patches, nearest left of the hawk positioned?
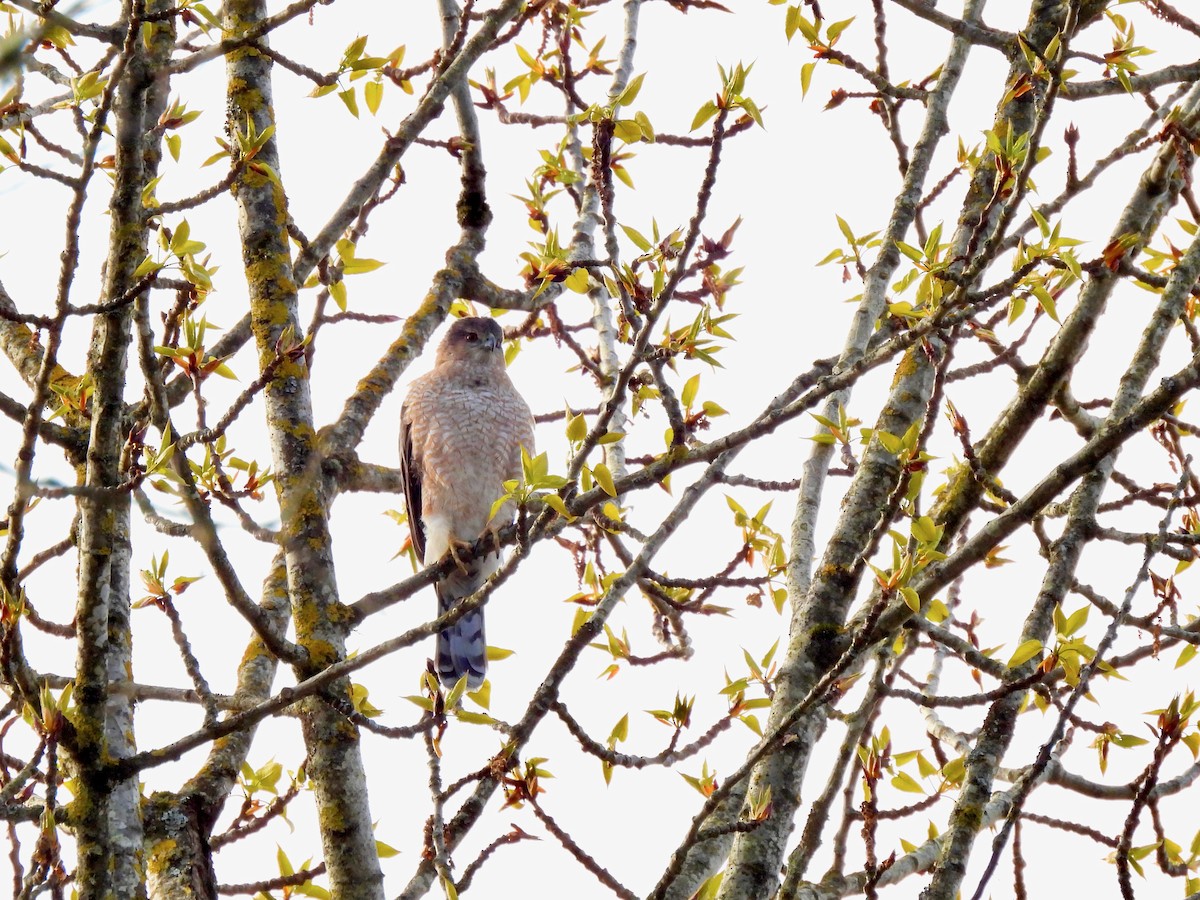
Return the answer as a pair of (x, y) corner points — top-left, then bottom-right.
(224, 0), (383, 900)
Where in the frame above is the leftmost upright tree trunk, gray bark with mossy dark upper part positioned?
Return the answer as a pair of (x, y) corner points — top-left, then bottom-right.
(71, 2), (174, 898)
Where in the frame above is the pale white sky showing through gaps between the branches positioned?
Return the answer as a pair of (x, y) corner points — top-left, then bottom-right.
(0, 0), (1190, 899)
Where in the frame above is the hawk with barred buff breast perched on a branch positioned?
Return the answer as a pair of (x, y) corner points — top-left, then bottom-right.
(400, 318), (534, 690)
